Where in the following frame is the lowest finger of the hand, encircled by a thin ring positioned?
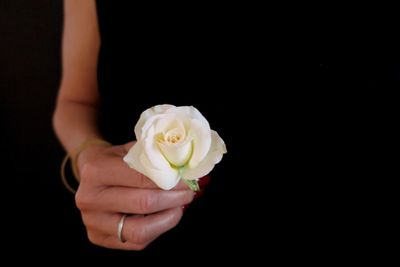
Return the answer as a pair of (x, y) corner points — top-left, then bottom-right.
(83, 207), (182, 250)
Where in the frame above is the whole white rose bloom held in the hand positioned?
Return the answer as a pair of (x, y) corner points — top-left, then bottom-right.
(124, 105), (226, 190)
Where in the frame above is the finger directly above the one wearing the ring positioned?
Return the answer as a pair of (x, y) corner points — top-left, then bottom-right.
(76, 187), (194, 214)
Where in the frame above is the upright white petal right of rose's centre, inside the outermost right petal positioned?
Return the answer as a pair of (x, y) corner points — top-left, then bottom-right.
(188, 119), (211, 168)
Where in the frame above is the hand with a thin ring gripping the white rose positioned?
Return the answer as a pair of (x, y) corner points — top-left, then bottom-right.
(75, 142), (194, 250)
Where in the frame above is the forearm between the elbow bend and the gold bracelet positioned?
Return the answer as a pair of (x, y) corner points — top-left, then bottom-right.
(53, 99), (102, 153)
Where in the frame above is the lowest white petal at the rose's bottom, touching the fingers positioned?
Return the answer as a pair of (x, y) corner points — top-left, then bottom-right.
(140, 154), (179, 190)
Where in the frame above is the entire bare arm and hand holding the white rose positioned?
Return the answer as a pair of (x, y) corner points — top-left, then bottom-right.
(53, 0), (194, 250)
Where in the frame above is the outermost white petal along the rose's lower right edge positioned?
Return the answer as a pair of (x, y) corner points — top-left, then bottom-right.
(183, 131), (226, 180)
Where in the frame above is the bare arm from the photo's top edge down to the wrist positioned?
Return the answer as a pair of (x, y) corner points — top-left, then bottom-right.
(53, 0), (101, 152)
